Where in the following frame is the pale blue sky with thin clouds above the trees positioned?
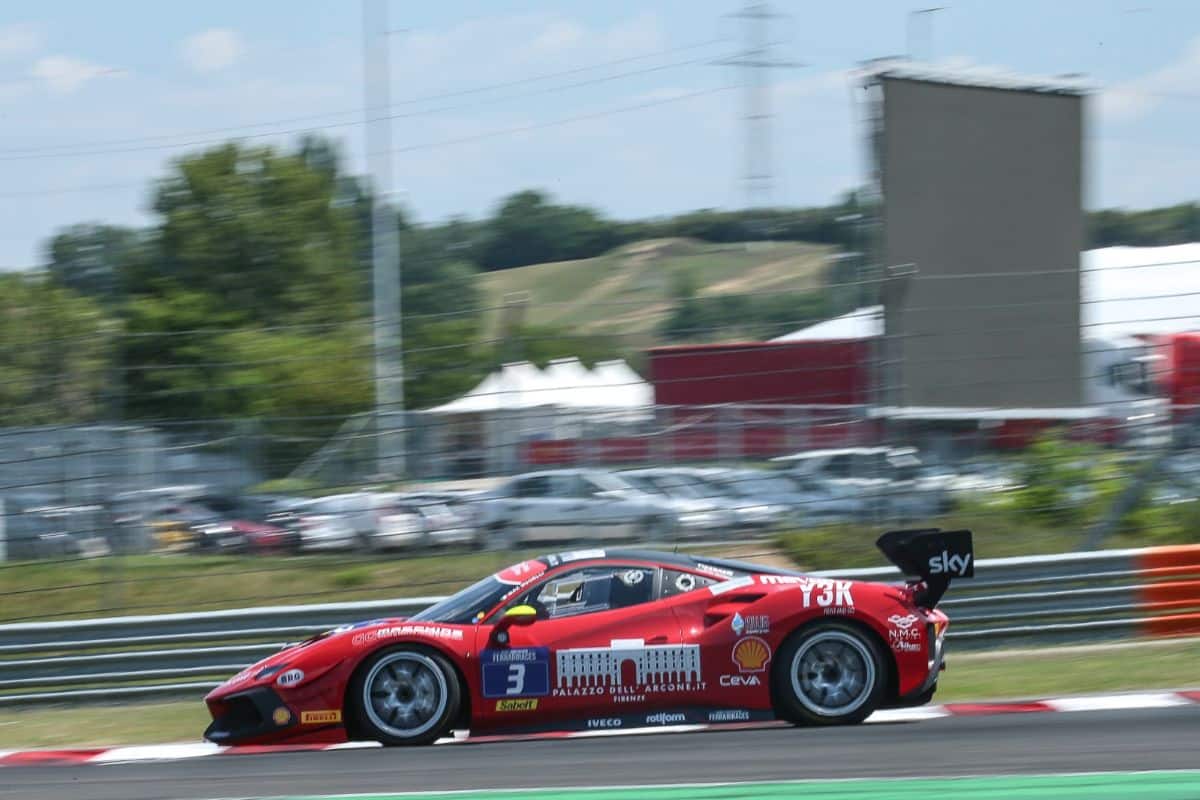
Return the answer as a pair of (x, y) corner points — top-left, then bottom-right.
(0, 0), (1200, 269)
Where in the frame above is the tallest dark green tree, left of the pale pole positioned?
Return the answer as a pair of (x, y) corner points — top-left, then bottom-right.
(149, 144), (361, 325)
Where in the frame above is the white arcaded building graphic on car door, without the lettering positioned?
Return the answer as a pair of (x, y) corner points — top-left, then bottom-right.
(556, 639), (700, 690)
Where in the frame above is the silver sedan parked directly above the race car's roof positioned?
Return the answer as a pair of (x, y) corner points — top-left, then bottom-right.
(479, 469), (680, 548)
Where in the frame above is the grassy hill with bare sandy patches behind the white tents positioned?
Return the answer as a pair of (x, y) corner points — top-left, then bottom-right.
(479, 239), (832, 343)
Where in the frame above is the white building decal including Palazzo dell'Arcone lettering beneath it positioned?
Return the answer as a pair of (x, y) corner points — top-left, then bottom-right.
(551, 639), (706, 703)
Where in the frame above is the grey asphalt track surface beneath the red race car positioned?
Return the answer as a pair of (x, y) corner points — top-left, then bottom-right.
(0, 705), (1200, 800)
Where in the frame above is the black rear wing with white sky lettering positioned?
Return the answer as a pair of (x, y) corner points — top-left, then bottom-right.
(875, 528), (974, 608)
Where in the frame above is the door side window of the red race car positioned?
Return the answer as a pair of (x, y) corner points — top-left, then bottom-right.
(517, 566), (654, 619)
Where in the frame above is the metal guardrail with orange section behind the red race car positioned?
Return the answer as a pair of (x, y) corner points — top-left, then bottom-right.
(0, 546), (1200, 705)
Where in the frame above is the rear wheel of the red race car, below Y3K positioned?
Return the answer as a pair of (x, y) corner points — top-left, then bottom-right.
(772, 620), (888, 726)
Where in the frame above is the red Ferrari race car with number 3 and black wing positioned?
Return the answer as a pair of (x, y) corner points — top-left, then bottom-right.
(204, 529), (974, 745)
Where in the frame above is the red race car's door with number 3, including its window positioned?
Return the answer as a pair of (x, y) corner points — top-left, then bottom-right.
(479, 564), (702, 729)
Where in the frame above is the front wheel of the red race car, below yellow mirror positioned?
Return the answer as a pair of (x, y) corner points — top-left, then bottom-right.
(346, 645), (462, 746)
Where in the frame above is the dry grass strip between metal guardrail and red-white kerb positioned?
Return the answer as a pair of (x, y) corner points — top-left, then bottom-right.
(0, 639), (1200, 748)
